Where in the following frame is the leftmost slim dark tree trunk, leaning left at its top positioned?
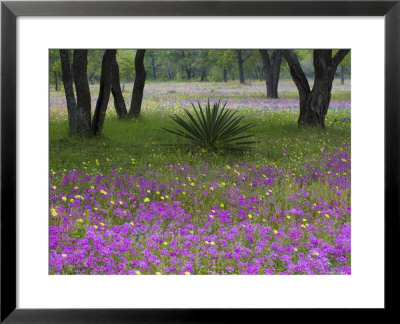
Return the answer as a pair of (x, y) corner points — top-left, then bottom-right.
(60, 50), (76, 135)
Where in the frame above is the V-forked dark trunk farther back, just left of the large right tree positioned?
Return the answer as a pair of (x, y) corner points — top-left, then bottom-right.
(259, 49), (282, 99)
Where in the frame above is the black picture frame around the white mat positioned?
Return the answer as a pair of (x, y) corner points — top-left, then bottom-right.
(0, 0), (400, 323)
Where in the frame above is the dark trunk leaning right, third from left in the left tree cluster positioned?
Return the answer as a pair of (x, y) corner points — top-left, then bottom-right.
(92, 50), (115, 135)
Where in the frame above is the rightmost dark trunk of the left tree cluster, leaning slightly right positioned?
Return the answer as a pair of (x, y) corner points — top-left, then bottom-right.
(129, 49), (146, 117)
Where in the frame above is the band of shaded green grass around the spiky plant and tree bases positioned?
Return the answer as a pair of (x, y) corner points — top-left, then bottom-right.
(50, 111), (350, 173)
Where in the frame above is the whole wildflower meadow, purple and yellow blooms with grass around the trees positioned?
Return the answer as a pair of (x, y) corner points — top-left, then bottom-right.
(49, 81), (351, 275)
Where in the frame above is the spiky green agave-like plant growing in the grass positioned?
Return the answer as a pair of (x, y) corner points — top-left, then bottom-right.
(163, 100), (255, 150)
